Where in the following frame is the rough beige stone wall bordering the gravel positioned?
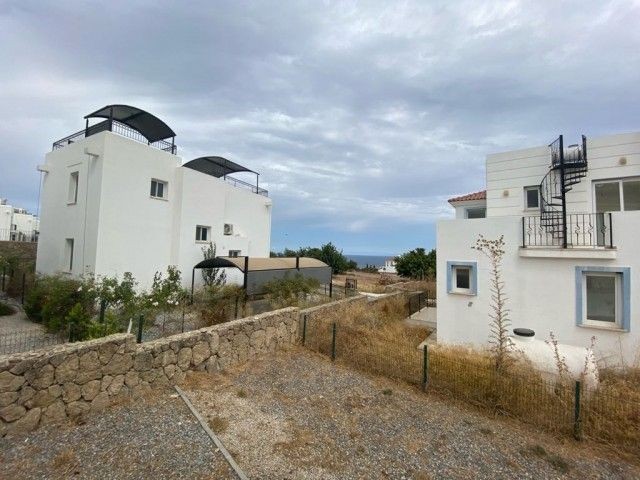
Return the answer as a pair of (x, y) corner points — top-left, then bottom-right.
(0, 308), (299, 436)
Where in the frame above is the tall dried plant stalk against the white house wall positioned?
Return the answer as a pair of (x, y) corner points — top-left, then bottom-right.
(471, 235), (514, 372)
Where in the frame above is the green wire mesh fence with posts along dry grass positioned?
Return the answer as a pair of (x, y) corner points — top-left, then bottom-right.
(301, 317), (640, 455)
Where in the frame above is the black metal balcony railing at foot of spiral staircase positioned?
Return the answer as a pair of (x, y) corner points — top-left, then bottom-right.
(522, 213), (614, 248)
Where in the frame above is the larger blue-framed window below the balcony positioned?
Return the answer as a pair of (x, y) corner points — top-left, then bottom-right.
(576, 267), (631, 332)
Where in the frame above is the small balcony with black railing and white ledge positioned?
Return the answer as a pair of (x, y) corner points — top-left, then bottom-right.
(520, 213), (616, 259)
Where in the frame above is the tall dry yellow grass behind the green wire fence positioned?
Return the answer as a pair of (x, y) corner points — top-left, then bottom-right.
(306, 297), (640, 460)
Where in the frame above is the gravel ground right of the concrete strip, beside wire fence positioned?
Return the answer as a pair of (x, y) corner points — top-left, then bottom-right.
(183, 349), (640, 479)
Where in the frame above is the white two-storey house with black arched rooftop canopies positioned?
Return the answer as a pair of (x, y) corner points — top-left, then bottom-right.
(36, 105), (272, 288)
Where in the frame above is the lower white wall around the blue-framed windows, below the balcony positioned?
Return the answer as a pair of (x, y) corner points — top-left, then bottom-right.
(437, 212), (640, 363)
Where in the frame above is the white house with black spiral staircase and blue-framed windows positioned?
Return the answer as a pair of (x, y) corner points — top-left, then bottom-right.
(437, 129), (640, 365)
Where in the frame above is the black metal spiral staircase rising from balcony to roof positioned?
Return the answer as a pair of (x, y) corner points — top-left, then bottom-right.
(540, 135), (588, 248)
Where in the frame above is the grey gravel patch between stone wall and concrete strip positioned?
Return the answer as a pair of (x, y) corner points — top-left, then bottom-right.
(0, 390), (235, 480)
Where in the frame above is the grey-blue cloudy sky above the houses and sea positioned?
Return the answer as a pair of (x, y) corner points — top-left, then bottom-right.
(0, 0), (640, 254)
